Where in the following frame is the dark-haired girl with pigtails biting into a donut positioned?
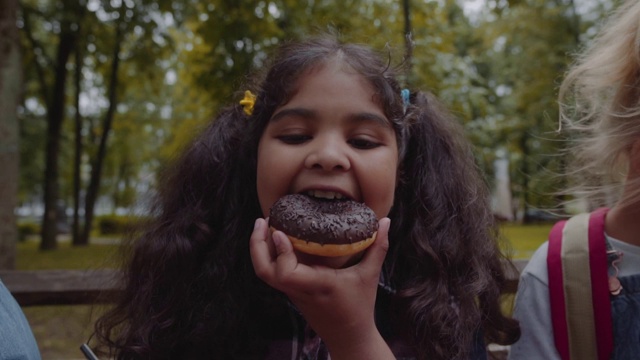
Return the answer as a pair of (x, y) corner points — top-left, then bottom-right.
(91, 36), (519, 360)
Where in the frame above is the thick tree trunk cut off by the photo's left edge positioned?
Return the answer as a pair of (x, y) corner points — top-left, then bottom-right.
(0, 0), (22, 269)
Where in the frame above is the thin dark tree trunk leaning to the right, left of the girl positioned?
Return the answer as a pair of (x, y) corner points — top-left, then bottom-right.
(79, 24), (123, 245)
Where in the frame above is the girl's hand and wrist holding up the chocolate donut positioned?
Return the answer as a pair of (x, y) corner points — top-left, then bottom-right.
(250, 218), (394, 360)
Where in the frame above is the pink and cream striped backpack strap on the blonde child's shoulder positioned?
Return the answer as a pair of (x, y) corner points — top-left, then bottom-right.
(547, 209), (613, 360)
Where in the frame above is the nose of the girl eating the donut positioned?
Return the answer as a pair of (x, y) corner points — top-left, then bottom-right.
(304, 139), (351, 171)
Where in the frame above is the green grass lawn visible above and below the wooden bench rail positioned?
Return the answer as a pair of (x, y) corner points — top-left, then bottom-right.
(16, 224), (551, 360)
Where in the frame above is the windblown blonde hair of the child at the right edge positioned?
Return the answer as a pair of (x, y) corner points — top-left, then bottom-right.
(559, 0), (640, 208)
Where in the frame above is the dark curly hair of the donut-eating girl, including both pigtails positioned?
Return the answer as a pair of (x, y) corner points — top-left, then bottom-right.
(95, 36), (519, 360)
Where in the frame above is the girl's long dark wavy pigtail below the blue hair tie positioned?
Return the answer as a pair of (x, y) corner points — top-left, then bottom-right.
(391, 92), (517, 359)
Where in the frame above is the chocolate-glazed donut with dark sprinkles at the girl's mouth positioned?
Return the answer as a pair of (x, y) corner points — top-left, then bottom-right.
(269, 194), (378, 256)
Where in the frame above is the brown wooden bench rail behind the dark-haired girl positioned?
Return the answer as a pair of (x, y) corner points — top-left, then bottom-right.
(0, 260), (527, 307)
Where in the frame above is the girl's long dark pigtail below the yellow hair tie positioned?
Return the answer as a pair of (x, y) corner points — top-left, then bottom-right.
(96, 106), (270, 359)
